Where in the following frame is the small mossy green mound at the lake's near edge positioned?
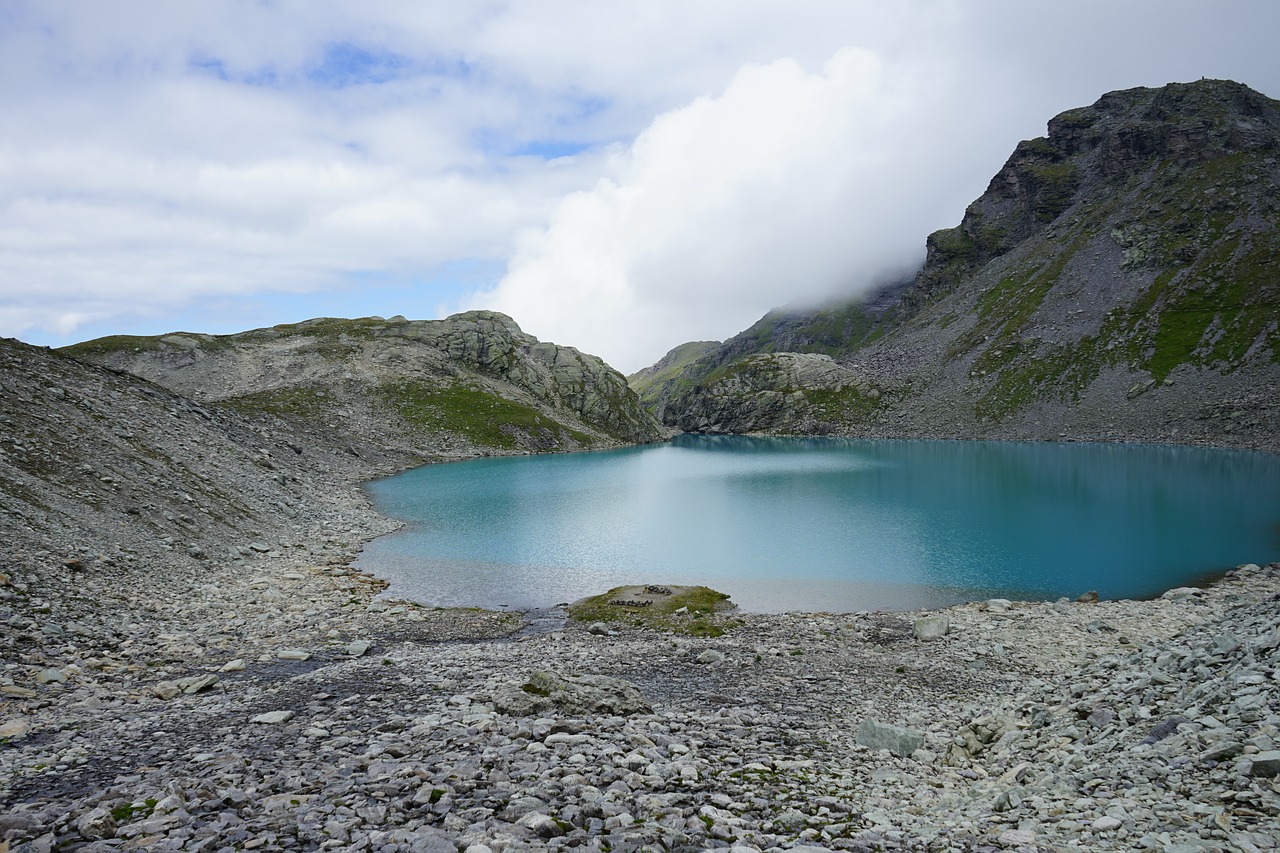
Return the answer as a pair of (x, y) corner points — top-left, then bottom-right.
(568, 587), (737, 637)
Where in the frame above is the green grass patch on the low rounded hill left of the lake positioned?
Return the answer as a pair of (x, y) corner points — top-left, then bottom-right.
(378, 379), (594, 450)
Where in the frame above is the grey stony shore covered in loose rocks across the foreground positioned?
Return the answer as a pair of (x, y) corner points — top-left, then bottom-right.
(0, 458), (1280, 853)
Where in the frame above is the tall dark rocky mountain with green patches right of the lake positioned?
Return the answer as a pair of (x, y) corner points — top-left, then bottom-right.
(650, 81), (1280, 448)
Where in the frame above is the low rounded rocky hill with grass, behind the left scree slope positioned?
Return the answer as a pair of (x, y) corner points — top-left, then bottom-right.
(67, 311), (663, 457)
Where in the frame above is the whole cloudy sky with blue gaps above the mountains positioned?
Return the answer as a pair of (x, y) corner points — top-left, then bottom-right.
(0, 0), (1280, 373)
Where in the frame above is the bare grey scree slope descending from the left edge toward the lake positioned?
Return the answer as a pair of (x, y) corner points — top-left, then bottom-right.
(0, 338), (412, 578)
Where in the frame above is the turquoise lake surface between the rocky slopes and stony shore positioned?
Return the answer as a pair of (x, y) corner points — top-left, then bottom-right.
(357, 435), (1280, 612)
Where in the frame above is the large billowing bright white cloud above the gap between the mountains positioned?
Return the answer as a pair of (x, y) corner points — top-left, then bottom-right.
(474, 49), (963, 371)
